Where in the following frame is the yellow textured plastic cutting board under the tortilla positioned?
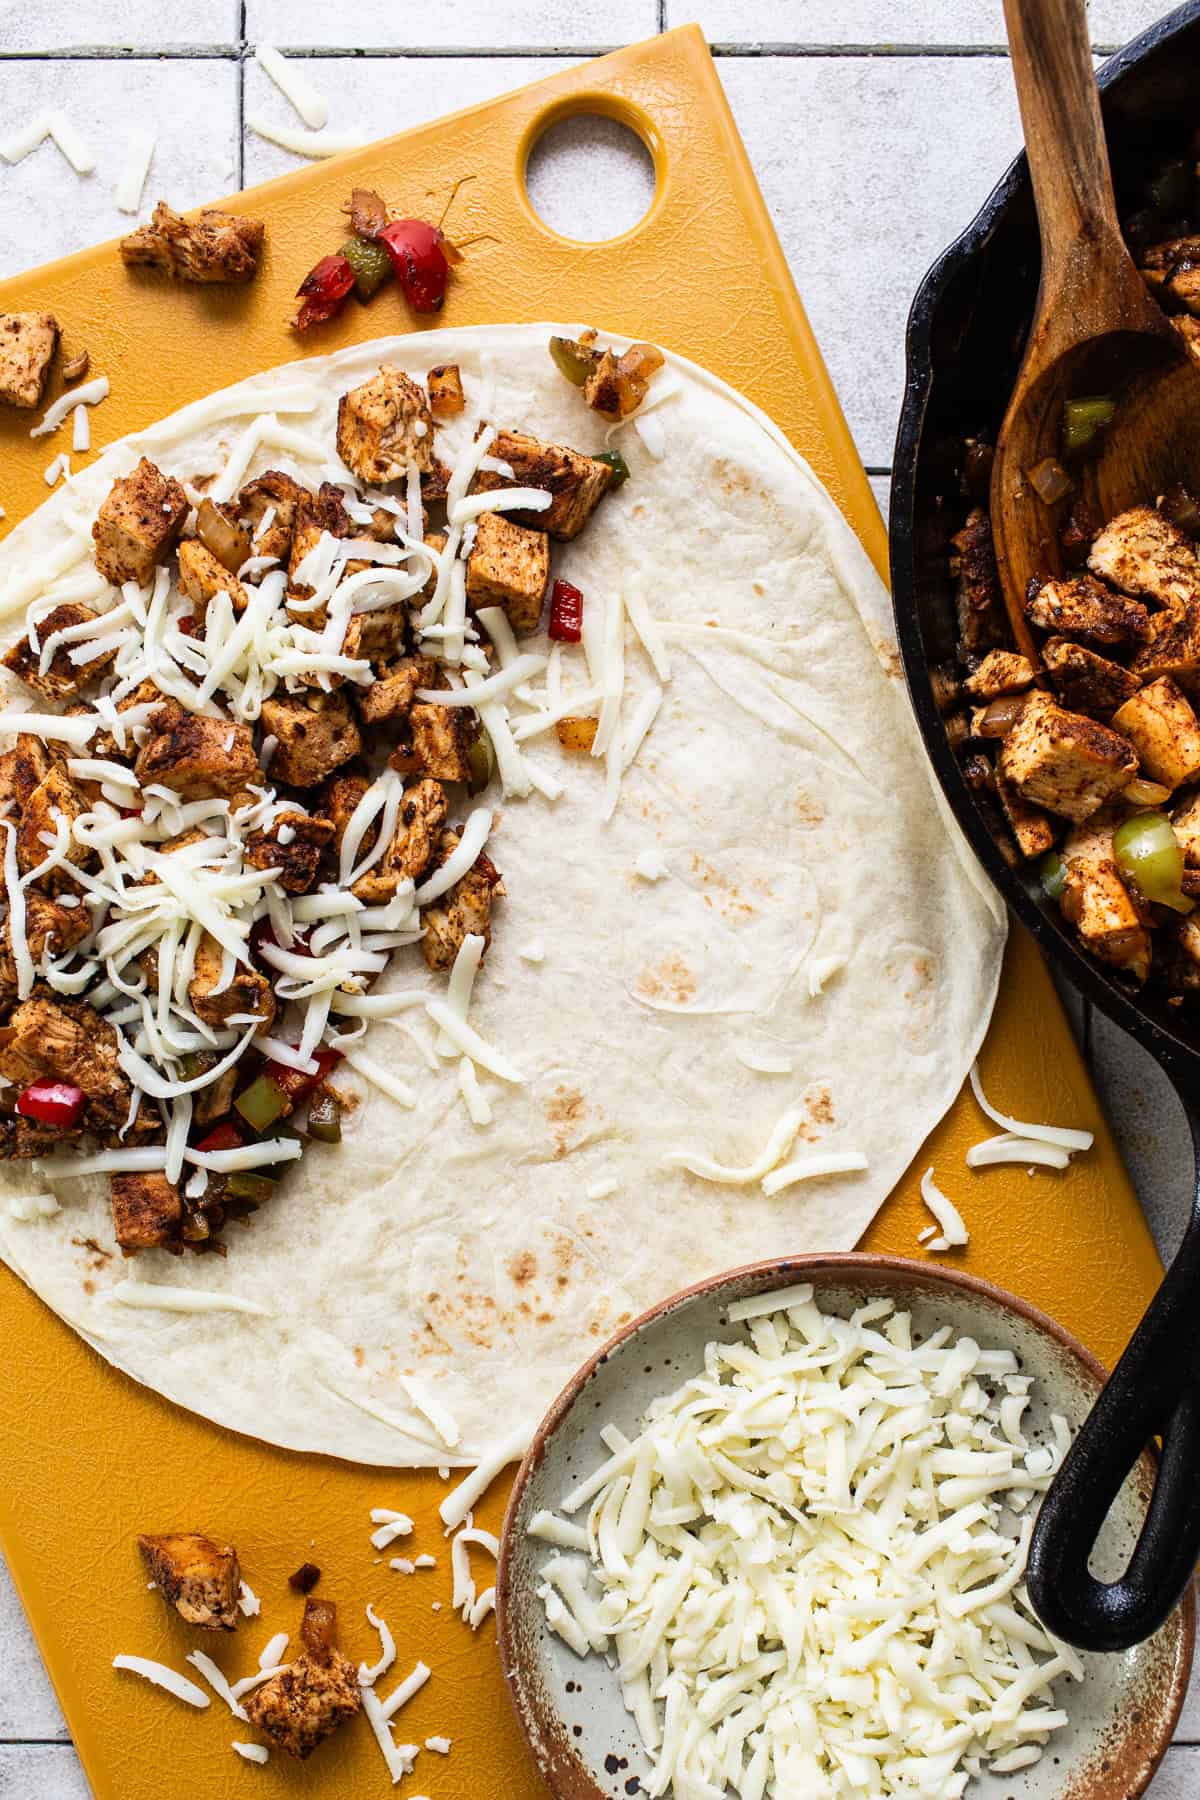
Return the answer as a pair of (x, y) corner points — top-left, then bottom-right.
(0, 27), (1160, 1800)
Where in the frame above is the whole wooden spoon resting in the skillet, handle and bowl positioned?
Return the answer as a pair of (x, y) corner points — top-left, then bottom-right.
(991, 0), (1200, 668)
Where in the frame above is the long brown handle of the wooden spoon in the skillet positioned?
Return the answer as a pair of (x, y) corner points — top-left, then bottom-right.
(1004, 0), (1128, 288)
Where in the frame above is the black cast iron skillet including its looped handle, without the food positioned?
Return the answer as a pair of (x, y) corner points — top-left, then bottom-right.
(891, 0), (1200, 1651)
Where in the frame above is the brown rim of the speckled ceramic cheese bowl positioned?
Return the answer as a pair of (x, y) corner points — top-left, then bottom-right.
(497, 1251), (1196, 1800)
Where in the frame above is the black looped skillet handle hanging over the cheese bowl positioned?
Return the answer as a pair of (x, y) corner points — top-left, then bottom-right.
(1027, 1159), (1200, 1651)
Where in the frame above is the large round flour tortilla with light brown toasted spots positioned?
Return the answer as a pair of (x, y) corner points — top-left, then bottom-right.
(0, 324), (1004, 1465)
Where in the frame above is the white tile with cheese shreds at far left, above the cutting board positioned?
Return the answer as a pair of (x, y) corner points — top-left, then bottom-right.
(0, 59), (237, 275)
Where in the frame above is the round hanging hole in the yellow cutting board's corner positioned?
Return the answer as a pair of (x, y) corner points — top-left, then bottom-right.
(525, 112), (655, 243)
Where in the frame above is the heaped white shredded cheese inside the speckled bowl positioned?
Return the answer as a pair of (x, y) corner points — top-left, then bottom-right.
(531, 1287), (1083, 1800)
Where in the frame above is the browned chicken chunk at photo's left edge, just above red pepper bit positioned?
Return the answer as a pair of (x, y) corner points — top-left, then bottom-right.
(0, 995), (131, 1132)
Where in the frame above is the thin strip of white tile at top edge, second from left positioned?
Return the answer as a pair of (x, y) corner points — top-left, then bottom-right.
(246, 0), (657, 48)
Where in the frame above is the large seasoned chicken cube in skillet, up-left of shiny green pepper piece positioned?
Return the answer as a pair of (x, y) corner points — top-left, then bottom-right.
(999, 691), (1137, 824)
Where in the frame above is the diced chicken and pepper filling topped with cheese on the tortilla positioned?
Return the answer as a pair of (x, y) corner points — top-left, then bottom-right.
(0, 352), (615, 1252)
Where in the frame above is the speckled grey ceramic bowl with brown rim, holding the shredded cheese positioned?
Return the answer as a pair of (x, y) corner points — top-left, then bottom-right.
(497, 1255), (1195, 1800)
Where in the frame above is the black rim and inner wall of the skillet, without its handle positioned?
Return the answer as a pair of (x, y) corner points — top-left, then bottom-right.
(891, 0), (1200, 1100)
